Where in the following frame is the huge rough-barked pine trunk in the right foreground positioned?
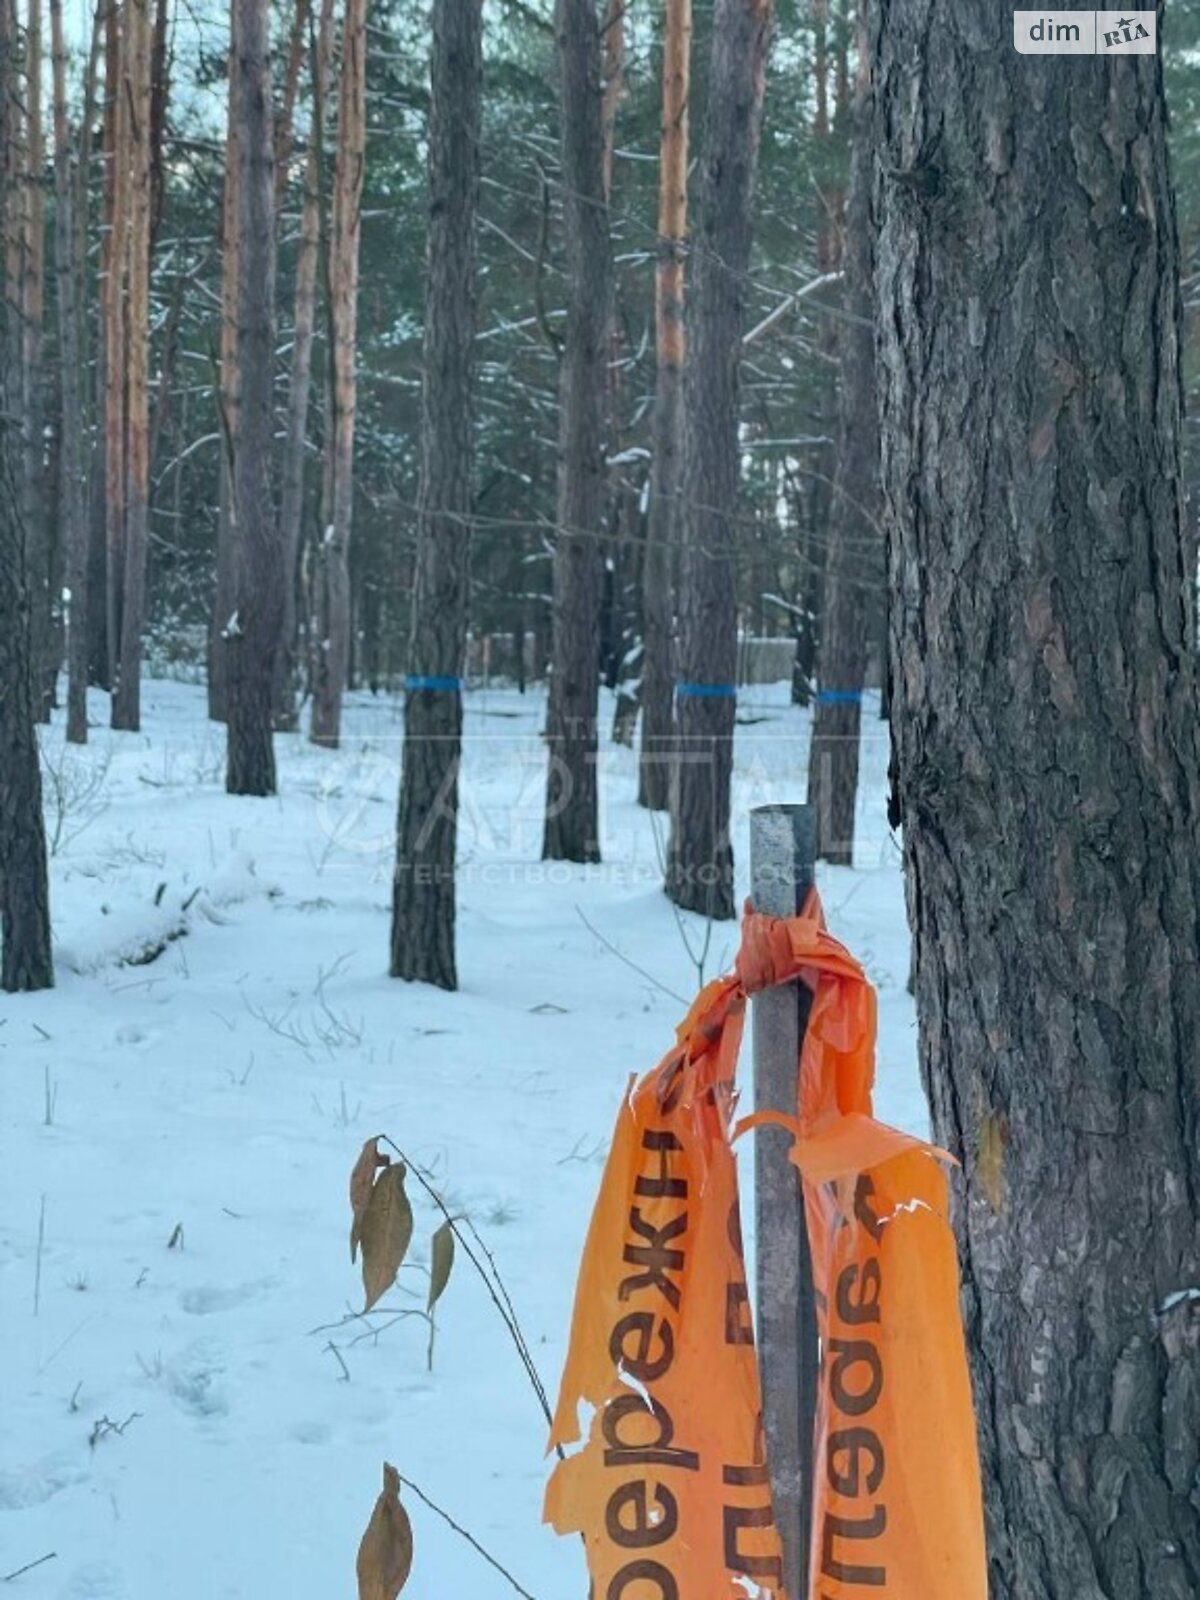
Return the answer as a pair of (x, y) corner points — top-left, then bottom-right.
(875, 0), (1200, 1600)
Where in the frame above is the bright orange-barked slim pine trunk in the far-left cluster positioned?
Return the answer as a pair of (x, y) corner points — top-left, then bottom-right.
(112, 0), (154, 733)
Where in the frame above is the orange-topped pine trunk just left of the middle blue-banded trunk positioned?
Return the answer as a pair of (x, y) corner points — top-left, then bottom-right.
(637, 0), (691, 811)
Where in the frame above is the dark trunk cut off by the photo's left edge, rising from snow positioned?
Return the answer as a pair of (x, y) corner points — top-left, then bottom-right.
(0, 0), (54, 994)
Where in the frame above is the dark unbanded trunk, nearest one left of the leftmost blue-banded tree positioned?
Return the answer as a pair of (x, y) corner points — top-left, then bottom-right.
(222, 0), (283, 795)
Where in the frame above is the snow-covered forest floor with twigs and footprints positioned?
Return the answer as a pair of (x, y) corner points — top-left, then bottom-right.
(0, 683), (925, 1600)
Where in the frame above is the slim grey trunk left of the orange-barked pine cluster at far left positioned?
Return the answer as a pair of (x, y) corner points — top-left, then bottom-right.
(50, 0), (88, 744)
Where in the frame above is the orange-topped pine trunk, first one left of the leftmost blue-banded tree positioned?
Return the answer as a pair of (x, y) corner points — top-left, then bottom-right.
(312, 0), (366, 749)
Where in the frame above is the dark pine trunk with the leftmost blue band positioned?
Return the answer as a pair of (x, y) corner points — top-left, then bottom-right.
(392, 0), (483, 989)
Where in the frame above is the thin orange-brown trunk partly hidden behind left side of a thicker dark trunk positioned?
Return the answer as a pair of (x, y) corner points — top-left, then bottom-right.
(208, 14), (243, 722)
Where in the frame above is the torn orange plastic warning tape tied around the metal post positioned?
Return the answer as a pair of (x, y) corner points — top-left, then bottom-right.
(546, 896), (987, 1600)
